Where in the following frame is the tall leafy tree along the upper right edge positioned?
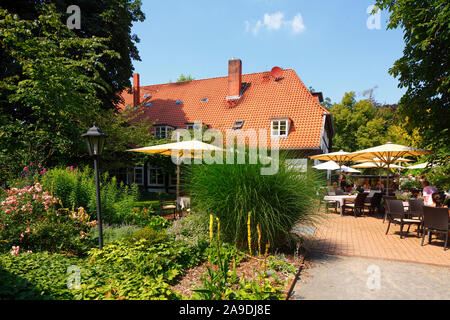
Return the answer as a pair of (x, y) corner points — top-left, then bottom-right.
(376, 0), (450, 159)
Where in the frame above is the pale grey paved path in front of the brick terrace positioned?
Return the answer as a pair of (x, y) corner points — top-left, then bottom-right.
(292, 249), (450, 300)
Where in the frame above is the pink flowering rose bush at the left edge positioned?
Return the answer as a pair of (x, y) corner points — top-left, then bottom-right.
(0, 182), (97, 255)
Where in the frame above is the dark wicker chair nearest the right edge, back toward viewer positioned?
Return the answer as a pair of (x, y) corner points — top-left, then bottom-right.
(422, 206), (449, 251)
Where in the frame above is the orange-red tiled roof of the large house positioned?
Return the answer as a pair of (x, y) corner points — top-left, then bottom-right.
(119, 69), (329, 149)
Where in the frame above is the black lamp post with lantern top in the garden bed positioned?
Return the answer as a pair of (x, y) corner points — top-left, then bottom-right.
(81, 124), (107, 250)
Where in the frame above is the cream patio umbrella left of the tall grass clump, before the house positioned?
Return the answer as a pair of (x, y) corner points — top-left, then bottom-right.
(127, 140), (224, 216)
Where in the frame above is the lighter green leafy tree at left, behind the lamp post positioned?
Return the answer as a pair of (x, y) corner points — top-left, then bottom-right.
(0, 5), (150, 181)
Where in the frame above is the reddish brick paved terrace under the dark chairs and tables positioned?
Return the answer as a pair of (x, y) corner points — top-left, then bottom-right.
(296, 211), (450, 267)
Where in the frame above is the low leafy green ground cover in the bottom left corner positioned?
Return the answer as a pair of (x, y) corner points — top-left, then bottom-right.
(0, 253), (181, 300)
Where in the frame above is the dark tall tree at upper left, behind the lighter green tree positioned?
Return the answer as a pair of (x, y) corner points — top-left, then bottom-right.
(0, 0), (145, 109)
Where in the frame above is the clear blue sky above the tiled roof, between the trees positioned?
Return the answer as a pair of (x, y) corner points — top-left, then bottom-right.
(132, 0), (404, 103)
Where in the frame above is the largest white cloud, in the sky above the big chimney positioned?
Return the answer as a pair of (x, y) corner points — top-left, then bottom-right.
(245, 11), (306, 36)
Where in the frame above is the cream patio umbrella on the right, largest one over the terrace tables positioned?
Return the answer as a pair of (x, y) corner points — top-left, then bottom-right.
(351, 142), (430, 194)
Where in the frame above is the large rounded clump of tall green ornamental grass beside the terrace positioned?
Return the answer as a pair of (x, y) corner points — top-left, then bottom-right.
(186, 154), (321, 249)
